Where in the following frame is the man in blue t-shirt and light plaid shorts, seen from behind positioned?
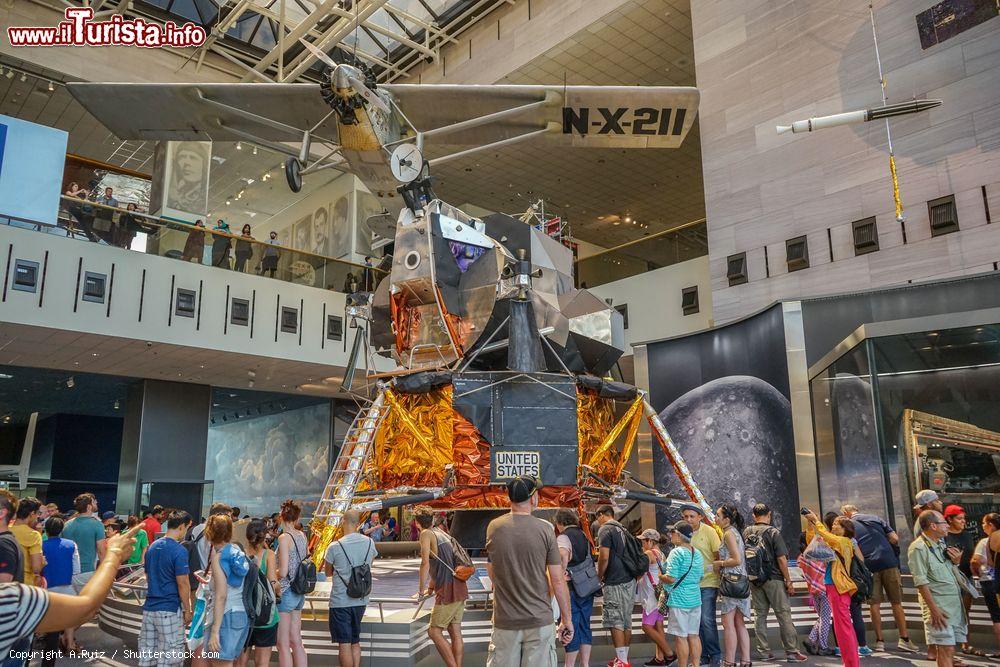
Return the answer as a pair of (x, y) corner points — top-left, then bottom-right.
(139, 511), (192, 667)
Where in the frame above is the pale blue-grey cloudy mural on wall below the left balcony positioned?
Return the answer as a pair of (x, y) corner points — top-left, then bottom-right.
(205, 402), (331, 516)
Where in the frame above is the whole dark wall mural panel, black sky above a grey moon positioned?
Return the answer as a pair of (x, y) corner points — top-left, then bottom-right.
(647, 306), (800, 550)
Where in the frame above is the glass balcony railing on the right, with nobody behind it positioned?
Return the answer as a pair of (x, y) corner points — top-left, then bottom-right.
(576, 218), (708, 287)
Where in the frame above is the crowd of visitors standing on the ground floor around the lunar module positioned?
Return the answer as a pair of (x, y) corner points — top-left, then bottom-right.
(0, 486), (1000, 667)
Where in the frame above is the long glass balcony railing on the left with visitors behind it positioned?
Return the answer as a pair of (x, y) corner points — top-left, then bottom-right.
(0, 197), (386, 293)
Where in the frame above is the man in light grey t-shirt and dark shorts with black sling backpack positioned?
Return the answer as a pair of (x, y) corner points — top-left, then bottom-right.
(324, 510), (376, 667)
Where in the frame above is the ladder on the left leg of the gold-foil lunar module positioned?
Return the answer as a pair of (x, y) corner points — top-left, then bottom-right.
(314, 392), (390, 527)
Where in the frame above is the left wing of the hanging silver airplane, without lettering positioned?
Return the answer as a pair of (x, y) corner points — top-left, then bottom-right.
(67, 83), (337, 142)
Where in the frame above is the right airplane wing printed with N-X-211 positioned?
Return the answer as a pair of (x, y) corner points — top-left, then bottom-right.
(380, 84), (700, 148)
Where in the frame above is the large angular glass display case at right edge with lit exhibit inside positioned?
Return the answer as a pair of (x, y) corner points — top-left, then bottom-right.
(810, 325), (1000, 564)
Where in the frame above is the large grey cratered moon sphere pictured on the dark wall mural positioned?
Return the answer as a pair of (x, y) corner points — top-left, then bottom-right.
(653, 375), (800, 552)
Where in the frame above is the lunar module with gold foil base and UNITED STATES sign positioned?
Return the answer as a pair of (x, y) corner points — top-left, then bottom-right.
(313, 179), (711, 555)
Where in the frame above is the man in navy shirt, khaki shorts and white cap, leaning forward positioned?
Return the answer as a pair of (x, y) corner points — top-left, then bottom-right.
(840, 505), (920, 653)
